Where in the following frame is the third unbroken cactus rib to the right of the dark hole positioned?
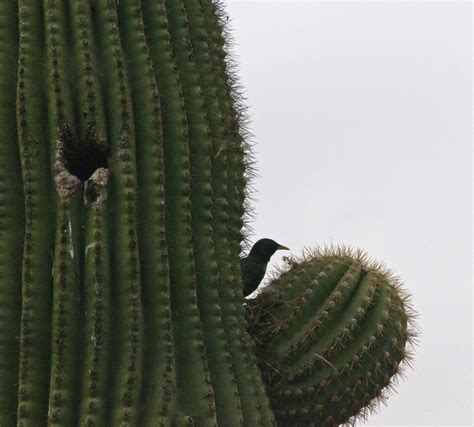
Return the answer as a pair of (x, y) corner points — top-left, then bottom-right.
(143, 1), (216, 424)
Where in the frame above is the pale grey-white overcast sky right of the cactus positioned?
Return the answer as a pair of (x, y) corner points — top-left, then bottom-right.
(226, 1), (472, 426)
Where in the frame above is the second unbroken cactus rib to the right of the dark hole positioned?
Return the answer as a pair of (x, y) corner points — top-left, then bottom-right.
(115, 1), (176, 426)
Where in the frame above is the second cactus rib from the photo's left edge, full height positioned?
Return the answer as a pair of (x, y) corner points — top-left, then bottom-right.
(17, 0), (53, 425)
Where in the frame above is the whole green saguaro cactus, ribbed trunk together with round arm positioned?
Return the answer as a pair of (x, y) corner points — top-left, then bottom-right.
(0, 0), (412, 427)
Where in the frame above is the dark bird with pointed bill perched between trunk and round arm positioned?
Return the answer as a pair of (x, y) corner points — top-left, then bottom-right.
(240, 239), (289, 297)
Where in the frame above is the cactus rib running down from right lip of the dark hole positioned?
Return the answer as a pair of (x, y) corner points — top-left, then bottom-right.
(79, 169), (112, 426)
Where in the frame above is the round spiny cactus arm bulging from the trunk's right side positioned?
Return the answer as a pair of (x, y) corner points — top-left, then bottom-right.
(247, 248), (416, 426)
